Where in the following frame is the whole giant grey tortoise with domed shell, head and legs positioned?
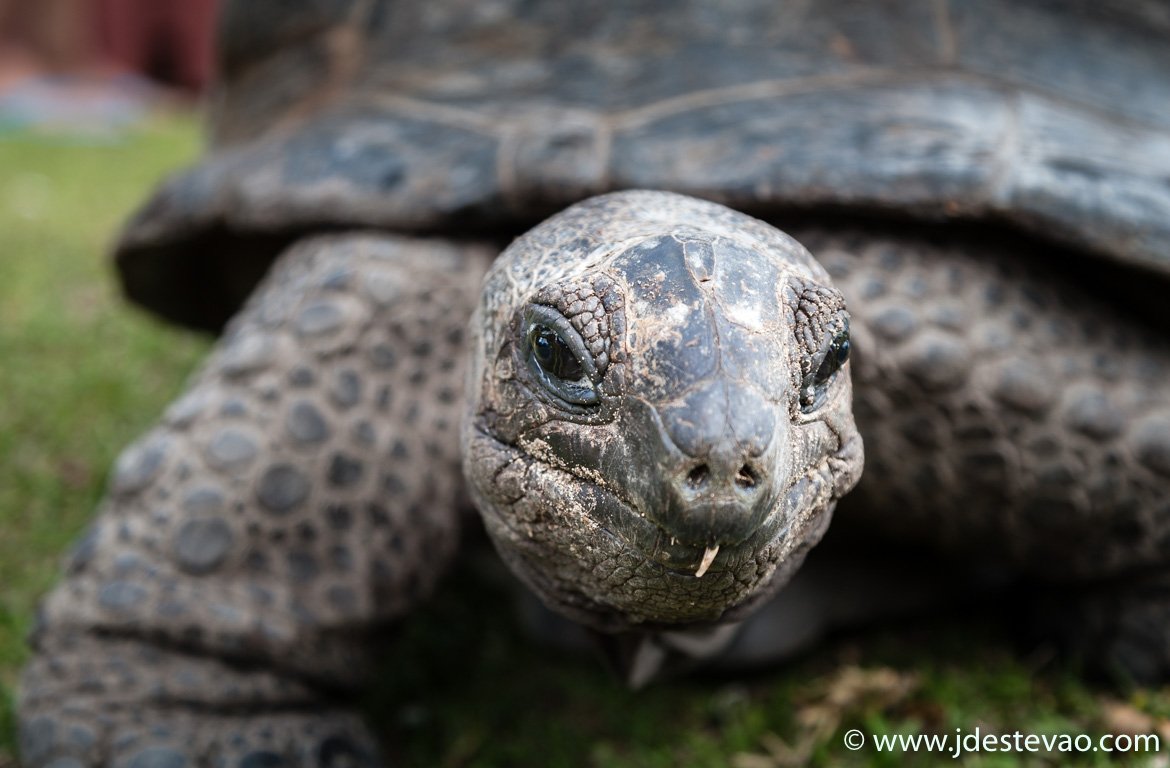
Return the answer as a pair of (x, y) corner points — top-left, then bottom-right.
(20, 0), (1170, 768)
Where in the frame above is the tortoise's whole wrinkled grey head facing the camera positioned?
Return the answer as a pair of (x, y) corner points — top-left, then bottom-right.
(463, 192), (862, 632)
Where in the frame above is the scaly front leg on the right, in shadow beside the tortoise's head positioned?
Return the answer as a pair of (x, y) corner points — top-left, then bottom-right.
(796, 225), (1170, 679)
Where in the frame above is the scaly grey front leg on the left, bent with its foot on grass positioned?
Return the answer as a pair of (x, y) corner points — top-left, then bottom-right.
(20, 235), (489, 768)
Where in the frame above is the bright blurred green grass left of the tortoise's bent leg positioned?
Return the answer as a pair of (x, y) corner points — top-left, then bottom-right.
(0, 118), (206, 753)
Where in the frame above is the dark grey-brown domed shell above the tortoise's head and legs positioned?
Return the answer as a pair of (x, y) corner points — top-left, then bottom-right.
(116, 0), (1170, 329)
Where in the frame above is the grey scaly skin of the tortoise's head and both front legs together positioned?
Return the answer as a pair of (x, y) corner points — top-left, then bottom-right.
(20, 193), (1170, 768)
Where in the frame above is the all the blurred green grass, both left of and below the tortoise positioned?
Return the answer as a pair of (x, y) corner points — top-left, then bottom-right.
(0, 116), (1170, 768)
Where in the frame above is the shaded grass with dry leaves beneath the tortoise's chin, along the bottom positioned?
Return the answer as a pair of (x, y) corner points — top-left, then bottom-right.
(372, 576), (1170, 768)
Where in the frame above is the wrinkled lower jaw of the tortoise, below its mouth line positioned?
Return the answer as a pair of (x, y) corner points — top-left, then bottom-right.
(464, 419), (835, 632)
